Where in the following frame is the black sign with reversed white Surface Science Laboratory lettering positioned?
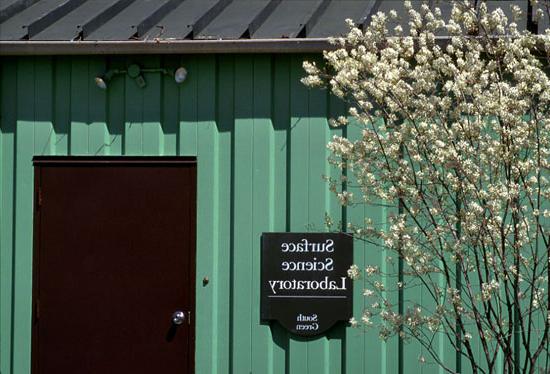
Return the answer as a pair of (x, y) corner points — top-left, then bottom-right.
(261, 233), (353, 336)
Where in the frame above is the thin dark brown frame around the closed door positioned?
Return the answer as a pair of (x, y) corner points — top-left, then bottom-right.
(31, 156), (198, 373)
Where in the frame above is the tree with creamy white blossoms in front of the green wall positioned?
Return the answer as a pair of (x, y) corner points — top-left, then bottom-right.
(303, 0), (550, 373)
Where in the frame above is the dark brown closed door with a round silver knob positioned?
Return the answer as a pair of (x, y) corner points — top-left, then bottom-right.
(33, 157), (196, 374)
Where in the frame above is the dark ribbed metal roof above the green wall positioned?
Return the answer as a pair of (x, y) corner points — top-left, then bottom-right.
(0, 0), (536, 54)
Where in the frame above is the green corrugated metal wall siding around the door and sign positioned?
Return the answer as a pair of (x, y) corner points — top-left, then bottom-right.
(0, 55), (462, 374)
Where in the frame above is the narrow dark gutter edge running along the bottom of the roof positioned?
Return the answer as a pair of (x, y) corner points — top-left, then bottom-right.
(0, 38), (336, 56)
